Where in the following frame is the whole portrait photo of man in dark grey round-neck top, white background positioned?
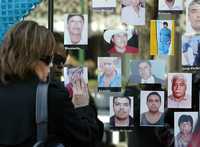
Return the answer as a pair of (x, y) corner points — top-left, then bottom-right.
(140, 91), (164, 126)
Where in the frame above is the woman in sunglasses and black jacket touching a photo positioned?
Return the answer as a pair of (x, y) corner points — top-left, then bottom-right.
(0, 21), (103, 147)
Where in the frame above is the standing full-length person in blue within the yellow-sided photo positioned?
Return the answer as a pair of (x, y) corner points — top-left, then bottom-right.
(157, 21), (171, 55)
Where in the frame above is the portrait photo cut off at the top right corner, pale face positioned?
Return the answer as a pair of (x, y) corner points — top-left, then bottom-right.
(185, 0), (200, 34)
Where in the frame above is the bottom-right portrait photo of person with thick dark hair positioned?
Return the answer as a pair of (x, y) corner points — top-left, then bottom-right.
(174, 112), (198, 147)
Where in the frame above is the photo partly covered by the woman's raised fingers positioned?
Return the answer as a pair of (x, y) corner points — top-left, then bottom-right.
(64, 67), (88, 87)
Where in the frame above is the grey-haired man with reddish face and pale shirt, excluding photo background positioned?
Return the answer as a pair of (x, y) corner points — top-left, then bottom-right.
(168, 74), (191, 108)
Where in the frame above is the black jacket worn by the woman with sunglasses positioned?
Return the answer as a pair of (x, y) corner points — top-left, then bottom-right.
(0, 78), (103, 147)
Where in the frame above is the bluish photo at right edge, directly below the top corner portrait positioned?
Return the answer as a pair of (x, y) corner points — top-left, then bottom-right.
(182, 35), (200, 66)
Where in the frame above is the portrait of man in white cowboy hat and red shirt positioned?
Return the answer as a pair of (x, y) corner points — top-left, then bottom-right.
(103, 29), (139, 55)
